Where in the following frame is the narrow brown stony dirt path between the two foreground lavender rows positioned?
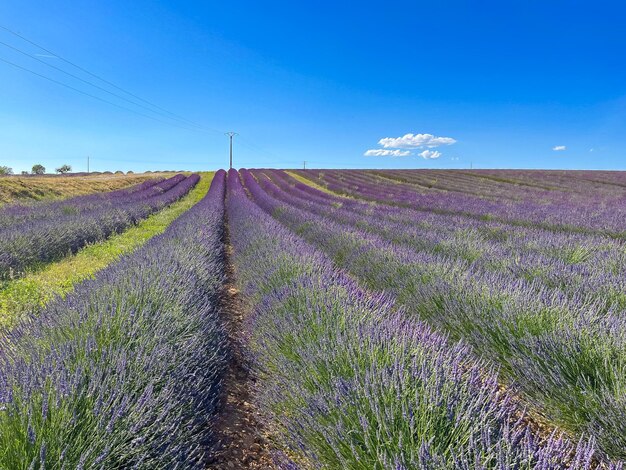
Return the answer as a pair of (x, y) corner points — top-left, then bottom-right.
(208, 219), (276, 470)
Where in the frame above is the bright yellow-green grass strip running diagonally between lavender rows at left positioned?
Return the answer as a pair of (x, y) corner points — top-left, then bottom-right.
(0, 172), (214, 327)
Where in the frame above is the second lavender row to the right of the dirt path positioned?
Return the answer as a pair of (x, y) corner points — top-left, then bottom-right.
(243, 171), (626, 458)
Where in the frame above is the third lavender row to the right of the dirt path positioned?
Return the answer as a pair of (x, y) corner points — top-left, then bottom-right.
(254, 170), (626, 310)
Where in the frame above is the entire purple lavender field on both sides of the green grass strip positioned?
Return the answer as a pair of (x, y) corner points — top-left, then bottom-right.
(0, 169), (626, 470)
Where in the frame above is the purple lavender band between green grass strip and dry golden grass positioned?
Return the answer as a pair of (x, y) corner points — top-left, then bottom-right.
(0, 174), (200, 281)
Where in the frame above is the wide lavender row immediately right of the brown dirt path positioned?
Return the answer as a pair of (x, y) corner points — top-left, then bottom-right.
(226, 170), (621, 469)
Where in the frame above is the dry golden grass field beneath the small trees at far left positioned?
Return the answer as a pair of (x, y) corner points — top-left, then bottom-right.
(0, 173), (171, 204)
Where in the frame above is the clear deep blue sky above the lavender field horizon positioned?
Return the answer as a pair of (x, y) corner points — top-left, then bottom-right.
(0, 0), (626, 171)
